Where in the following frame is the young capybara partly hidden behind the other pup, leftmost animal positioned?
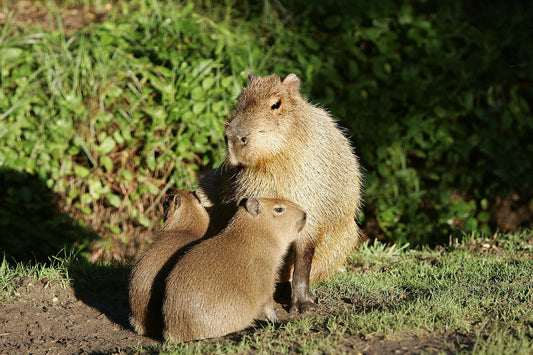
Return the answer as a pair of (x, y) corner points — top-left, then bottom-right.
(129, 190), (209, 338)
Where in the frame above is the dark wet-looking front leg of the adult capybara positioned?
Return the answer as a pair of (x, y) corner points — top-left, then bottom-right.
(290, 240), (315, 313)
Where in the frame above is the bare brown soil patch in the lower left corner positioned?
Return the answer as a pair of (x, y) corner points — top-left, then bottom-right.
(0, 279), (155, 354)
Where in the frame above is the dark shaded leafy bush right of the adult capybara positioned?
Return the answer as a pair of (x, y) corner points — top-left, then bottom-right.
(262, 1), (533, 244)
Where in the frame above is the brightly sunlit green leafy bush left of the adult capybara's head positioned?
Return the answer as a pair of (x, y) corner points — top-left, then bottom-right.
(0, 4), (236, 254)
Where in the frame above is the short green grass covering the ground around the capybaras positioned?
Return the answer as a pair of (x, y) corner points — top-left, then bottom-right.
(0, 230), (533, 354)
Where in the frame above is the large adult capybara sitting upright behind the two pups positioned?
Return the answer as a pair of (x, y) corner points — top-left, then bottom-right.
(197, 74), (362, 311)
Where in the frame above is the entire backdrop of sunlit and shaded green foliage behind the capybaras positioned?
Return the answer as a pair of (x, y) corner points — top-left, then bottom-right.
(0, 0), (533, 261)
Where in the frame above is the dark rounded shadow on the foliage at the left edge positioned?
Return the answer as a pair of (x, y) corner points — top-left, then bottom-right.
(0, 168), (99, 264)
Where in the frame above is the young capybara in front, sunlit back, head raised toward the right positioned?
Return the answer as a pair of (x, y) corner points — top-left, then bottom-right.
(163, 199), (306, 342)
